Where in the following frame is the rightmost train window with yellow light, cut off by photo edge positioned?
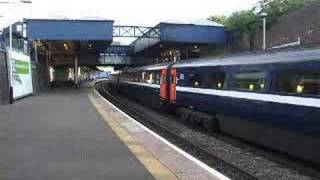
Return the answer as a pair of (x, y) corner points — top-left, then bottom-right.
(278, 73), (320, 95)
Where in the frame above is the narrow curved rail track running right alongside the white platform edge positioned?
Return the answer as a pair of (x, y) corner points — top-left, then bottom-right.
(95, 82), (258, 180)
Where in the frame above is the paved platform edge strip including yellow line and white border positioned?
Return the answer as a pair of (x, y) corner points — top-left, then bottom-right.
(89, 84), (230, 180)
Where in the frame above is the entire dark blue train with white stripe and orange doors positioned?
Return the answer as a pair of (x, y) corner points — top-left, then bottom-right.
(112, 49), (320, 164)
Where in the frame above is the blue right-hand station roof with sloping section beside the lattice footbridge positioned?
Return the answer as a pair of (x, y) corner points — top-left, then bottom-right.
(131, 21), (228, 53)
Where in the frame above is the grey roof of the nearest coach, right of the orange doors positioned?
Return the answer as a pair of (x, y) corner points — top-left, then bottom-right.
(173, 49), (320, 68)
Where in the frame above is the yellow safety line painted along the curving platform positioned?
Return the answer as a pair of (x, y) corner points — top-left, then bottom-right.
(89, 94), (178, 180)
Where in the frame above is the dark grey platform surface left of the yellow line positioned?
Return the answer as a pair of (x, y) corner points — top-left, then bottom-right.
(0, 89), (154, 180)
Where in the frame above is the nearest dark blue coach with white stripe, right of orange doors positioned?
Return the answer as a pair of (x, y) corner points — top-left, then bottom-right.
(172, 50), (320, 163)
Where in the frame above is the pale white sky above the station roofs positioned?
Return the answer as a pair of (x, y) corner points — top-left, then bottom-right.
(0, 0), (258, 44)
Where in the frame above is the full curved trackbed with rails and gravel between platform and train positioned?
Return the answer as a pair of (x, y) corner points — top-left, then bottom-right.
(96, 82), (320, 180)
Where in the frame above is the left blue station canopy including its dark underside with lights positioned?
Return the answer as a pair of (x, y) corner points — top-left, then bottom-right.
(25, 19), (114, 65)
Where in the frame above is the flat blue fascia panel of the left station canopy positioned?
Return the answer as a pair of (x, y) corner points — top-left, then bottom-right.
(25, 19), (114, 42)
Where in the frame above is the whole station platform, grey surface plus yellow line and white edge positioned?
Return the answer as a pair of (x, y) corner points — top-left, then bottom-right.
(0, 83), (228, 180)
